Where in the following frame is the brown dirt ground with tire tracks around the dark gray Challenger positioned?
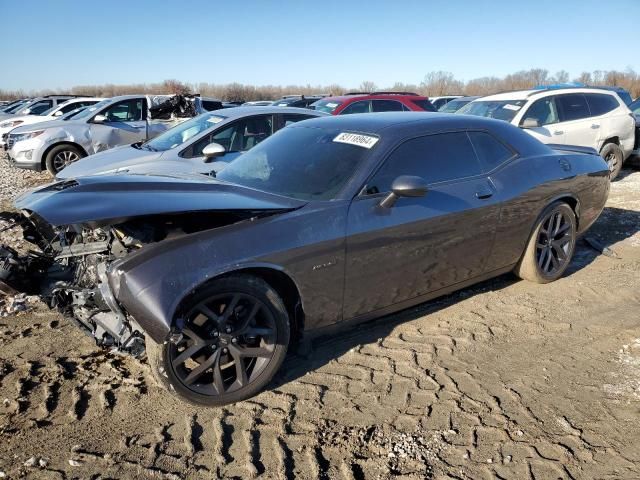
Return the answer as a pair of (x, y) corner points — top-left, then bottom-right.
(0, 159), (640, 479)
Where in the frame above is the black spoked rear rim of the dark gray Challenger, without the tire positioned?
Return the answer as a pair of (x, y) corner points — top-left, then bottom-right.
(536, 210), (574, 276)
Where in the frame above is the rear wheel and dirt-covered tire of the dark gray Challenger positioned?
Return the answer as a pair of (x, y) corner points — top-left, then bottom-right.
(515, 202), (577, 283)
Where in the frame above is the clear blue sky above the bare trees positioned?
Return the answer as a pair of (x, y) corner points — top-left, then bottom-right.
(0, 0), (640, 90)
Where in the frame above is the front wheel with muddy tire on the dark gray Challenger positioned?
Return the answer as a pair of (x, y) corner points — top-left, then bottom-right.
(146, 275), (290, 407)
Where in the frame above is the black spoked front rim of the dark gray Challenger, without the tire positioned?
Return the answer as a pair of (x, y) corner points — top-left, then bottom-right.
(168, 293), (277, 396)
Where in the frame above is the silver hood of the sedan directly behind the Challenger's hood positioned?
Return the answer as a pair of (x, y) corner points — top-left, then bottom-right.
(56, 145), (165, 179)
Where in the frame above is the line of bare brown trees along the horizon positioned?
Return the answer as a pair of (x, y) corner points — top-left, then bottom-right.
(0, 68), (640, 101)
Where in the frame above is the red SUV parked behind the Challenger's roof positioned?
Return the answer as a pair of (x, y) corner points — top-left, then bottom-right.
(311, 92), (436, 115)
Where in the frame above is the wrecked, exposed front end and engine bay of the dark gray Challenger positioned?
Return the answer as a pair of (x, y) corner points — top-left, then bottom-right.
(0, 210), (266, 356)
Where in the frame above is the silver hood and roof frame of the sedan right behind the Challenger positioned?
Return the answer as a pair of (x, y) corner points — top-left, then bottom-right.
(56, 106), (328, 179)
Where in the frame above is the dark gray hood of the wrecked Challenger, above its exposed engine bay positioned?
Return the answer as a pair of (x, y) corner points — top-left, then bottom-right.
(15, 174), (306, 226)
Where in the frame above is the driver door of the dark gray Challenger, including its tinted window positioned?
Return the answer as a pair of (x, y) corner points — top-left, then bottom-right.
(343, 132), (500, 320)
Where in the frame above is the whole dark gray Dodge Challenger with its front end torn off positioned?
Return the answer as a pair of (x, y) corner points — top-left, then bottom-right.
(0, 113), (609, 405)
